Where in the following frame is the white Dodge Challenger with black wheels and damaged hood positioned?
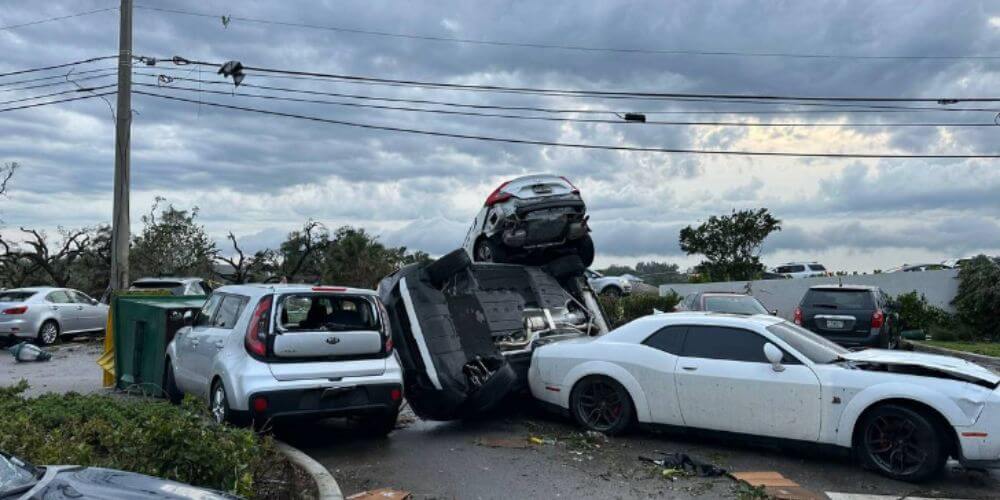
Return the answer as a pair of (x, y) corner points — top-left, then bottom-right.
(528, 313), (1000, 481)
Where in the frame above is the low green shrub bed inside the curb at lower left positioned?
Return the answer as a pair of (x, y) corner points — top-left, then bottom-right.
(0, 381), (284, 498)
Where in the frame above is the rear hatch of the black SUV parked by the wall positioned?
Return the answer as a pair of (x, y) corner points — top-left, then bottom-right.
(802, 288), (875, 336)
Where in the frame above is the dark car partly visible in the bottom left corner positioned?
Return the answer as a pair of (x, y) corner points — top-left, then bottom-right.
(0, 452), (239, 500)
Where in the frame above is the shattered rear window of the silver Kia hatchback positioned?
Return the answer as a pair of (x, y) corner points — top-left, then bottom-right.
(278, 294), (379, 332)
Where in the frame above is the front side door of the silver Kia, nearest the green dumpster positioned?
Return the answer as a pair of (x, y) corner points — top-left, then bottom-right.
(173, 293), (224, 395)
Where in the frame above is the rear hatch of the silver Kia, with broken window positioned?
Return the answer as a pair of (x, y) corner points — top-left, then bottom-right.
(269, 290), (388, 380)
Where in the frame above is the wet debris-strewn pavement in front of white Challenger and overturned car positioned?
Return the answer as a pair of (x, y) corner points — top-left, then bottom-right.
(276, 402), (1000, 499)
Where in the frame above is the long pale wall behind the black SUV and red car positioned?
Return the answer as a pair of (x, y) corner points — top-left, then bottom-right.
(660, 269), (958, 319)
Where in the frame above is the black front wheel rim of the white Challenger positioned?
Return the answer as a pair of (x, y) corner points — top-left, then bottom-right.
(865, 415), (927, 476)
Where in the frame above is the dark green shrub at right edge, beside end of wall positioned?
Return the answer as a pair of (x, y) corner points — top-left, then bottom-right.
(951, 255), (1000, 340)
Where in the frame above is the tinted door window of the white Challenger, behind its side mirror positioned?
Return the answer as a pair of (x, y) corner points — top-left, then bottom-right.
(683, 326), (768, 363)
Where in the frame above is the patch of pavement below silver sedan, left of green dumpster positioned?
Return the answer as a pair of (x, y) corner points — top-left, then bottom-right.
(0, 336), (104, 396)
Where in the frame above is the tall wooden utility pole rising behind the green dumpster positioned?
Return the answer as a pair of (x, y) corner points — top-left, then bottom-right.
(110, 0), (132, 290)
